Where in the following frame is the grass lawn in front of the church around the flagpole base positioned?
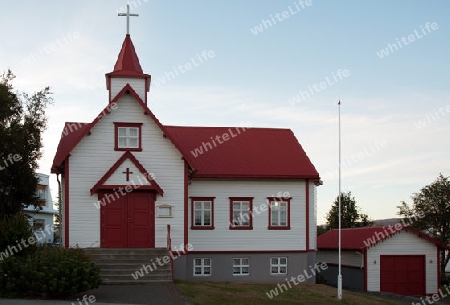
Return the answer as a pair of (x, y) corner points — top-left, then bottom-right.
(175, 280), (408, 305)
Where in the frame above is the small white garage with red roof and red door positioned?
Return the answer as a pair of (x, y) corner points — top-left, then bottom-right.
(316, 223), (450, 296)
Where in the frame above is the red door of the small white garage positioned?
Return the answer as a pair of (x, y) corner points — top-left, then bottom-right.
(380, 255), (425, 295)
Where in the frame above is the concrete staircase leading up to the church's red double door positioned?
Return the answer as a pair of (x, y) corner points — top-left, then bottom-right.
(85, 248), (172, 284)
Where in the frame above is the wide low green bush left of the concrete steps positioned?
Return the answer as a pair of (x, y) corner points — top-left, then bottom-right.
(0, 247), (101, 298)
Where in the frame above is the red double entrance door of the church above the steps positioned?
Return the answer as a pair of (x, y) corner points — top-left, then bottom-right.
(98, 191), (155, 248)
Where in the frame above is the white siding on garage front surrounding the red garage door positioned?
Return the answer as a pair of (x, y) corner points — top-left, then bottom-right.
(367, 231), (438, 294)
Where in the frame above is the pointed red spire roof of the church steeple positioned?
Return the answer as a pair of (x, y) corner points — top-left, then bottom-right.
(106, 34), (150, 77)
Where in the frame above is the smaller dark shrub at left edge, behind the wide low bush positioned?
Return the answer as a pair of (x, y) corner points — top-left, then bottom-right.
(0, 213), (36, 260)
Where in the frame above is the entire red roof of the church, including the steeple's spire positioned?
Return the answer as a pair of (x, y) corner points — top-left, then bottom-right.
(52, 35), (320, 180)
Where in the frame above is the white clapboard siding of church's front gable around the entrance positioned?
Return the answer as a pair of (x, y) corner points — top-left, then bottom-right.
(69, 95), (184, 247)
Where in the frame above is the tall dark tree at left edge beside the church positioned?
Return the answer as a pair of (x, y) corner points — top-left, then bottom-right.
(0, 71), (52, 216)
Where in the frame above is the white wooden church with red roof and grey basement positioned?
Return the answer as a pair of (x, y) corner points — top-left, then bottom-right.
(52, 13), (321, 282)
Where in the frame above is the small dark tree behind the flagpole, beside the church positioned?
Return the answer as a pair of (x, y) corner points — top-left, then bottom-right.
(327, 192), (372, 230)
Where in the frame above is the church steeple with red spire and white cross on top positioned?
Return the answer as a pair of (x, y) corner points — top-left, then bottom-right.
(105, 5), (151, 104)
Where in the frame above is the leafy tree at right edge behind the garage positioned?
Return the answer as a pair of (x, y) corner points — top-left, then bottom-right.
(397, 174), (450, 279)
